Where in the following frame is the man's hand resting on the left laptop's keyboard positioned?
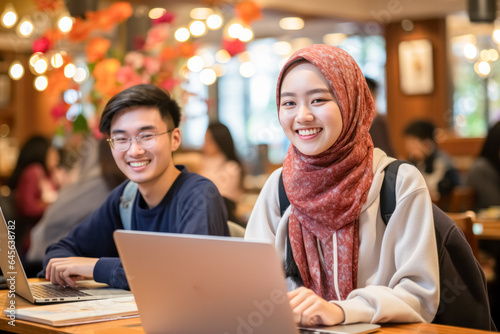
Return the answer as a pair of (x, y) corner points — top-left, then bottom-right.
(45, 257), (99, 287)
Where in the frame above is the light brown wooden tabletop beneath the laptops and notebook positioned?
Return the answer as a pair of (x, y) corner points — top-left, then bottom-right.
(0, 279), (491, 334)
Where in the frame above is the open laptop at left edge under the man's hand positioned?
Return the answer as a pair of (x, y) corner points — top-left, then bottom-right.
(0, 208), (131, 304)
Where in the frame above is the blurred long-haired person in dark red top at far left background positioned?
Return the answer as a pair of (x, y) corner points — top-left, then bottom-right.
(8, 136), (63, 256)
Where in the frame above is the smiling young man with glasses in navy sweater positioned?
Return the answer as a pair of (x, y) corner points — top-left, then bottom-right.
(42, 85), (229, 289)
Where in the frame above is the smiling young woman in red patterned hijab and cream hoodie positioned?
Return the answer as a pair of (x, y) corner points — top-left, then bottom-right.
(245, 45), (439, 326)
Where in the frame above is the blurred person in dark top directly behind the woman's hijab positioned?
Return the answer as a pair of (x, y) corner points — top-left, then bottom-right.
(365, 77), (396, 157)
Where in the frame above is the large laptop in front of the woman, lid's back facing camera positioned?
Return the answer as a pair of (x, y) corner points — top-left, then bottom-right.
(114, 230), (380, 334)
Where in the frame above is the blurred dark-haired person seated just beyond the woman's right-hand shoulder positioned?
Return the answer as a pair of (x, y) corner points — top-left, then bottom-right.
(404, 120), (460, 211)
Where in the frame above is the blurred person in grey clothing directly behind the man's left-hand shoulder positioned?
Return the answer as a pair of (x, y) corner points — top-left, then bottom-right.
(25, 138), (126, 277)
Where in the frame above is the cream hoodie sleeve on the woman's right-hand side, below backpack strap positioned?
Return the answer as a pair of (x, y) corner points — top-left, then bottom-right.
(332, 165), (439, 324)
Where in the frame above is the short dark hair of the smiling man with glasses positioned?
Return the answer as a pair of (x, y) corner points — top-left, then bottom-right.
(99, 84), (181, 134)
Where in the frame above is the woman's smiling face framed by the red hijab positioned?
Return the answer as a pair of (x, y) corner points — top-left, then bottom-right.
(279, 61), (342, 155)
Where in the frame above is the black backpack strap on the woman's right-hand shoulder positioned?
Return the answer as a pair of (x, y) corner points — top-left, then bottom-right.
(380, 160), (406, 225)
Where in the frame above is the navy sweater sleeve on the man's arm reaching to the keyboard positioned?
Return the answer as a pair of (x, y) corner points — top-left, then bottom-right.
(38, 185), (128, 289)
